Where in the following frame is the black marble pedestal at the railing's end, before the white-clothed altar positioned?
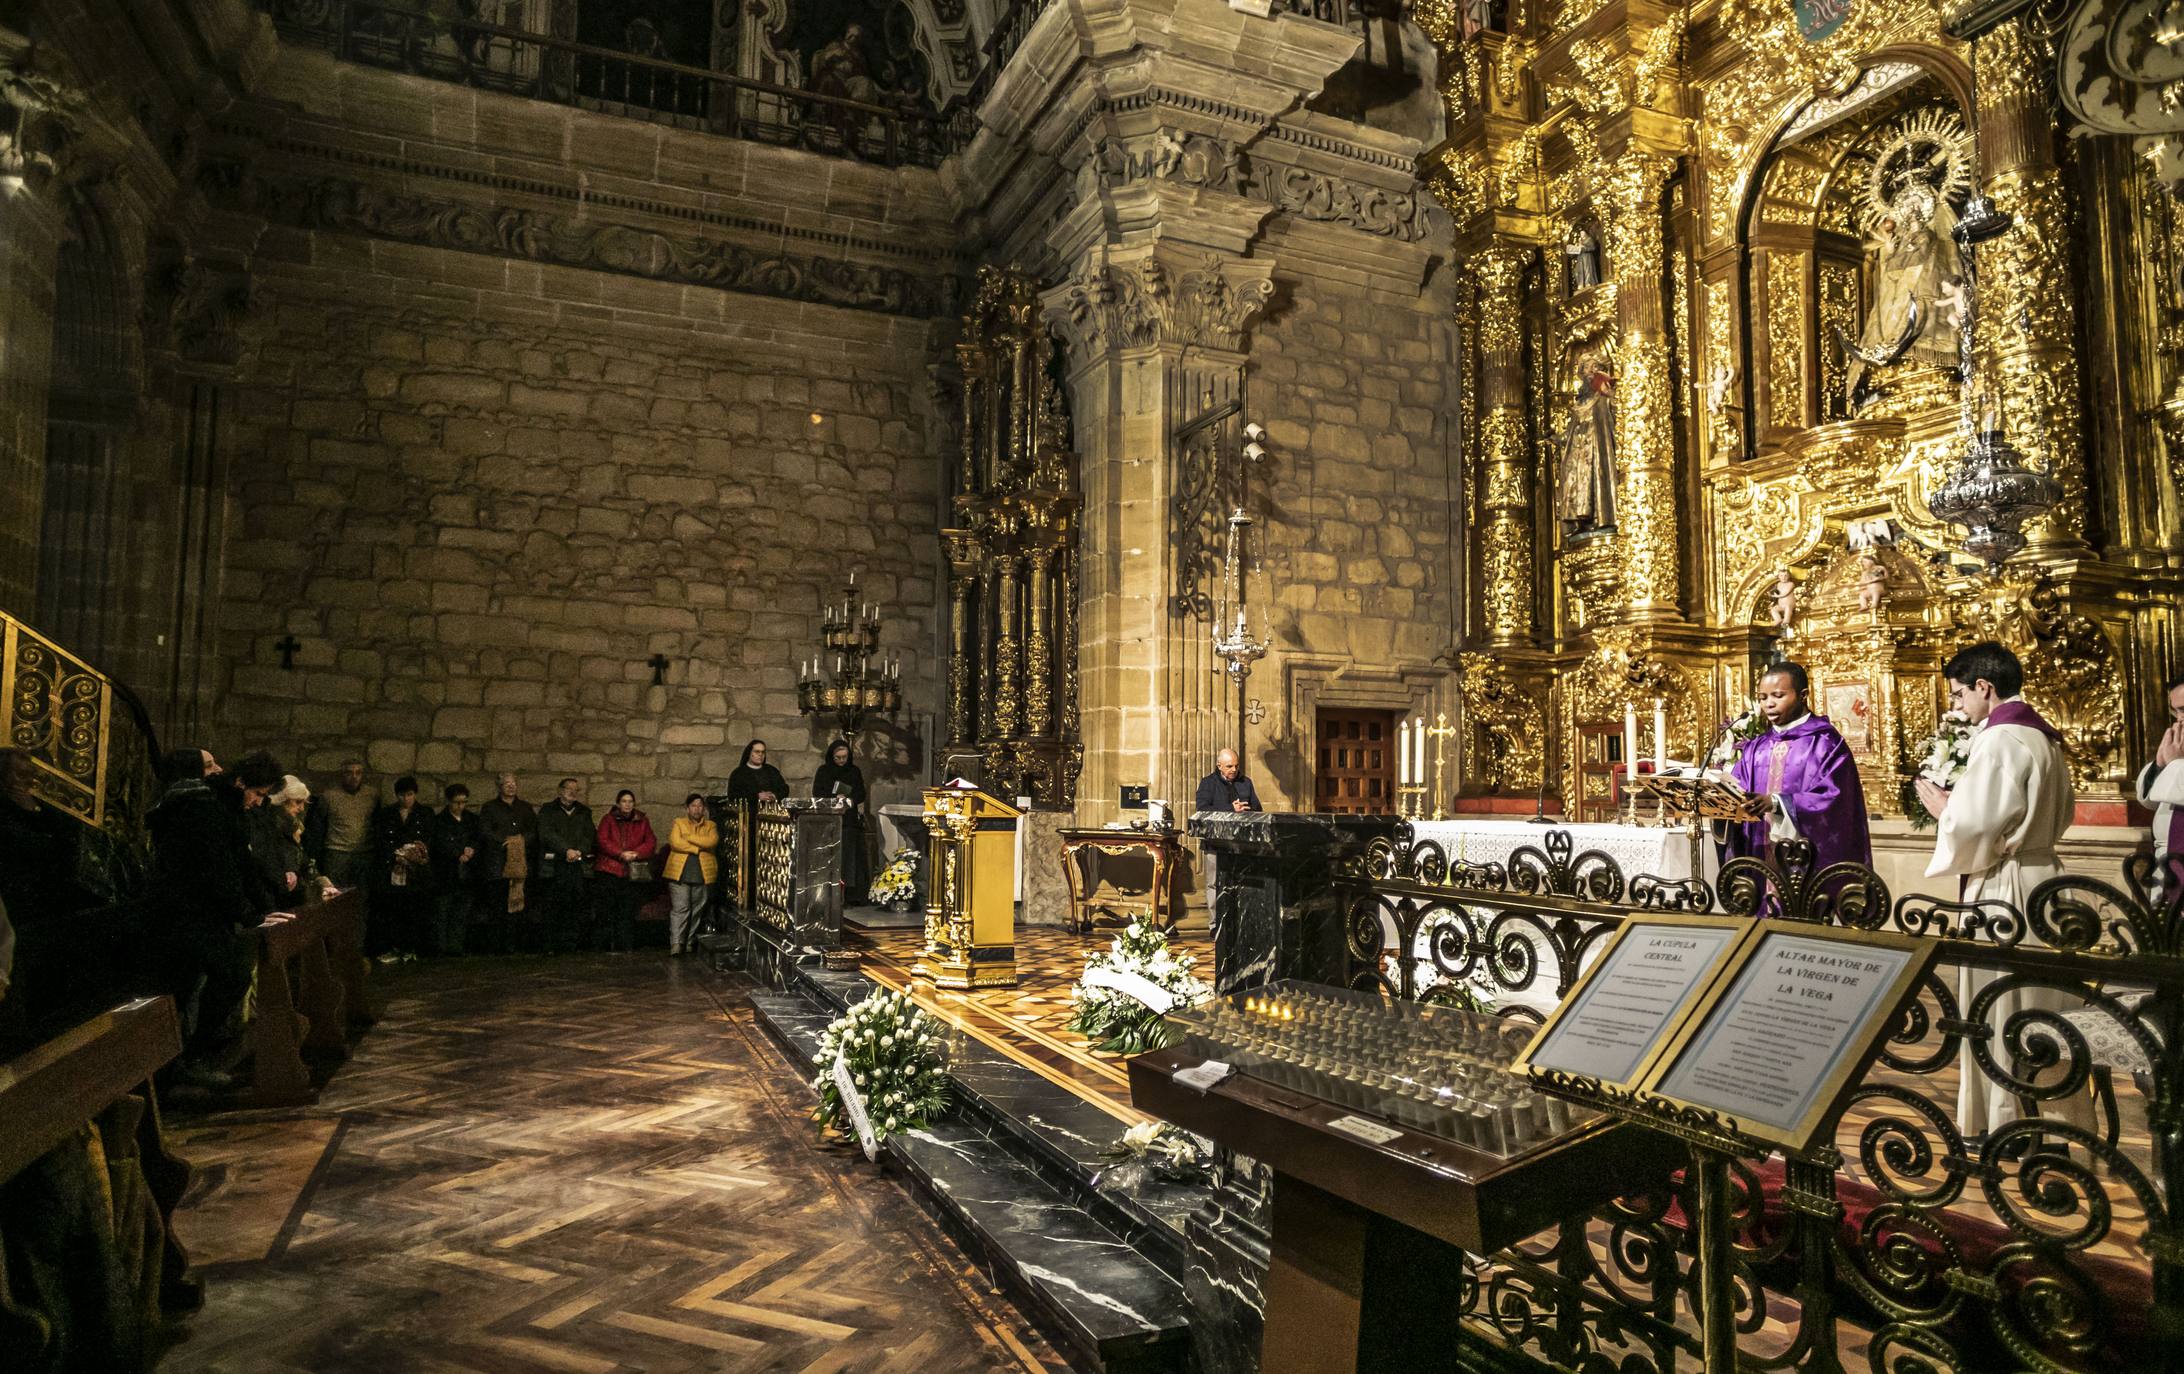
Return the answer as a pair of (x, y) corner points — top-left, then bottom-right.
(1190, 810), (1398, 992)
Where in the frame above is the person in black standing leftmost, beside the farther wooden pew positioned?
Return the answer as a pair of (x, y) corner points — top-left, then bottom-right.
(149, 749), (282, 1090)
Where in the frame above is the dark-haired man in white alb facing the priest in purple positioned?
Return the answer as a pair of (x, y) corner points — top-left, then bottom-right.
(1918, 642), (2092, 1138)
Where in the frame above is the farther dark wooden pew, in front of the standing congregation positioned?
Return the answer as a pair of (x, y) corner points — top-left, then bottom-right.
(249, 891), (376, 1108)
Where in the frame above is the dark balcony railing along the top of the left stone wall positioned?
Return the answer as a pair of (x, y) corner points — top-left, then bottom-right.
(258, 0), (959, 166)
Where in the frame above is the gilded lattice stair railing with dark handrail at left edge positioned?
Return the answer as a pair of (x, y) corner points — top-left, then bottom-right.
(0, 612), (157, 900)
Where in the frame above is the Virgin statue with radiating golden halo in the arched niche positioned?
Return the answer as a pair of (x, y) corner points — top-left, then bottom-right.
(1843, 109), (1972, 411)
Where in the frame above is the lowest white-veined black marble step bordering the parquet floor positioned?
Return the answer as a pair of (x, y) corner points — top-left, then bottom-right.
(751, 974), (1190, 1374)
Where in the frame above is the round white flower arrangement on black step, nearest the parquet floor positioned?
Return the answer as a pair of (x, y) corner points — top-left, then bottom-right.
(812, 990), (948, 1156)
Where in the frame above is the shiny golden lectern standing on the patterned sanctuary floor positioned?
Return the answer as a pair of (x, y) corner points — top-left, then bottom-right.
(915, 786), (1022, 987)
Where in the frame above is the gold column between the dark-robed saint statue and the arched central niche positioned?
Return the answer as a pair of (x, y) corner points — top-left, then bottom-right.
(1599, 146), (1679, 620)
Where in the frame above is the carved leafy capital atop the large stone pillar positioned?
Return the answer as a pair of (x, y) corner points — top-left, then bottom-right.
(1042, 253), (1273, 363)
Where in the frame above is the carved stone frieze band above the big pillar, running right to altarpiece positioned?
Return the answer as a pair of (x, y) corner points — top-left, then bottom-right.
(1096, 129), (1433, 242)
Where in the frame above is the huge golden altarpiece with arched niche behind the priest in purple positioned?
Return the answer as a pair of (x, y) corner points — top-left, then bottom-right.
(1417, 0), (2184, 813)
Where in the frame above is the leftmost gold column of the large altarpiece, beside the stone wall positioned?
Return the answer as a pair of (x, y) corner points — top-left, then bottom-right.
(1472, 240), (1531, 644)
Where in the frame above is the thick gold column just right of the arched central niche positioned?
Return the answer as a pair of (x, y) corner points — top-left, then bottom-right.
(1977, 17), (2086, 550)
